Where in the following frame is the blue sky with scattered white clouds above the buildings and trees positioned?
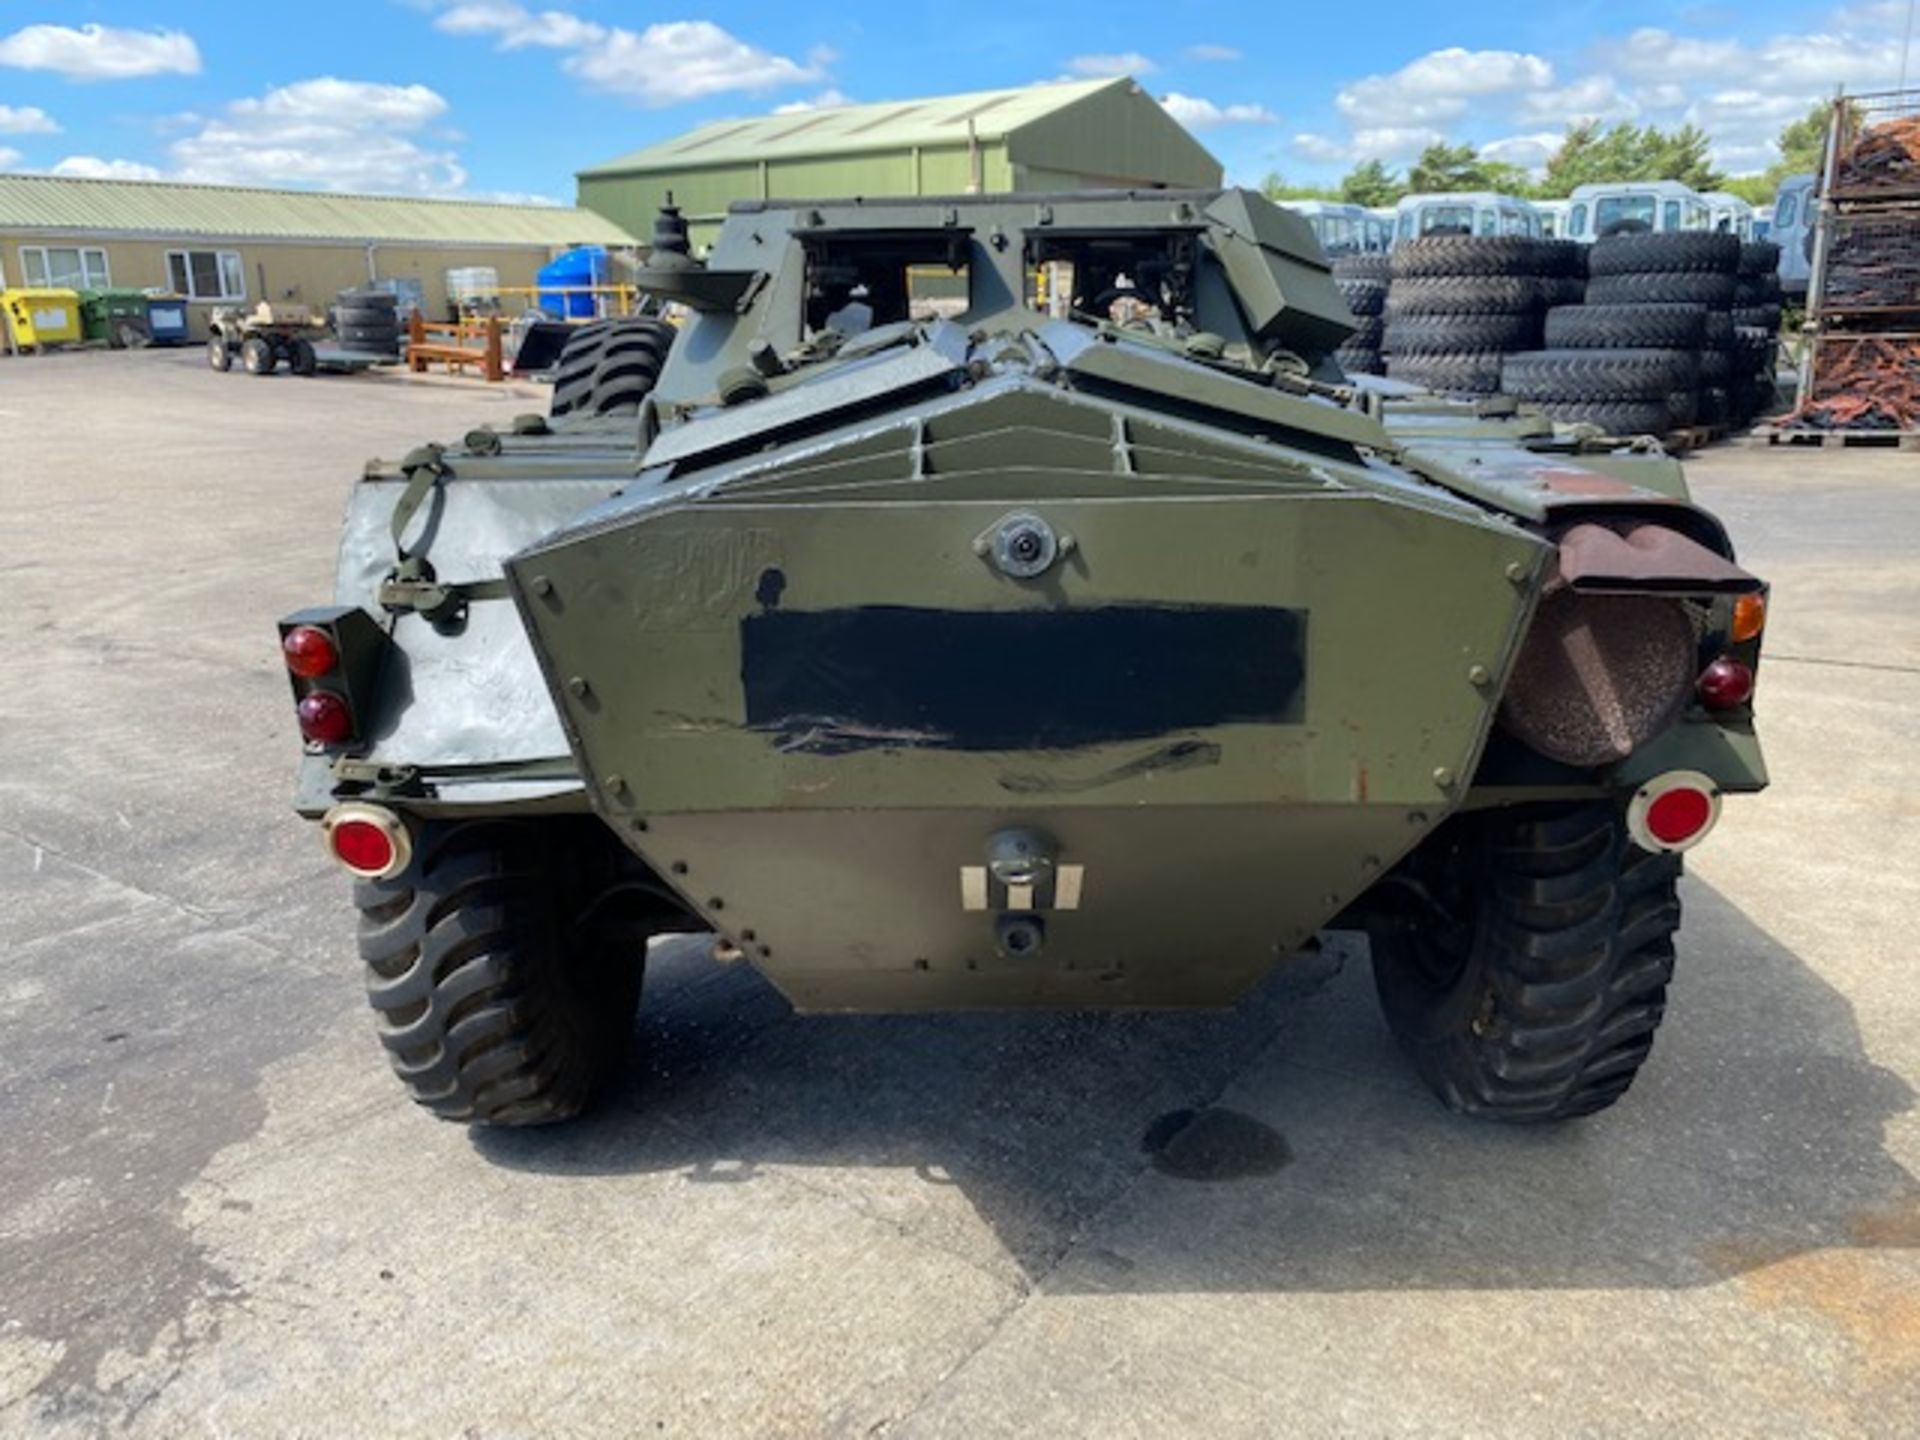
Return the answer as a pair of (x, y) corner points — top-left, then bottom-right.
(0, 0), (1920, 200)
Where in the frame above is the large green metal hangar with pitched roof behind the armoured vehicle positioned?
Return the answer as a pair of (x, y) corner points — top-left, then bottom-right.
(578, 77), (1221, 246)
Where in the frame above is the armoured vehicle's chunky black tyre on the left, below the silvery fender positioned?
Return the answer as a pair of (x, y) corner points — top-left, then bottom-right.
(353, 820), (645, 1125)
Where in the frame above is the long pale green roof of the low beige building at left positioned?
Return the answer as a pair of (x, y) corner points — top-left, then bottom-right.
(0, 175), (636, 246)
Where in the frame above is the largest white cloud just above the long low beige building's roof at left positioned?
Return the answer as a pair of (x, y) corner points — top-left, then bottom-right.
(167, 75), (467, 194)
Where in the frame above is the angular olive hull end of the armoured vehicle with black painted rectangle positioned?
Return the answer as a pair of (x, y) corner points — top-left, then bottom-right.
(509, 376), (1551, 1010)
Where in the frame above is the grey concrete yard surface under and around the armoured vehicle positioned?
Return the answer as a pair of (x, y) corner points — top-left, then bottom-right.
(0, 351), (1920, 1440)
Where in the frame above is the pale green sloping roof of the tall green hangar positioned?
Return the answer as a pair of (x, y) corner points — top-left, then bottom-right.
(580, 75), (1133, 177)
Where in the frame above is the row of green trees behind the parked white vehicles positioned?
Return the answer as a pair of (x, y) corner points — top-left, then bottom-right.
(1261, 104), (1830, 207)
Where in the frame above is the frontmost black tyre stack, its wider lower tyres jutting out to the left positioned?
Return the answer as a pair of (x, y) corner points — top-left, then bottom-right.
(1501, 232), (1740, 436)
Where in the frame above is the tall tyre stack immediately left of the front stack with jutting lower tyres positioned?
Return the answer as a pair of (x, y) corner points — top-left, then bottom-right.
(1382, 234), (1584, 396)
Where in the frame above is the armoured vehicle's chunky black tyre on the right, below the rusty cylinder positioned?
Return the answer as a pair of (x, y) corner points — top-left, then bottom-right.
(1373, 803), (1680, 1121)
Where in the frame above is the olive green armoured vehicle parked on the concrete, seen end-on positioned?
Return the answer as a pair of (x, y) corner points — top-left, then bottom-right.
(282, 190), (1764, 1125)
